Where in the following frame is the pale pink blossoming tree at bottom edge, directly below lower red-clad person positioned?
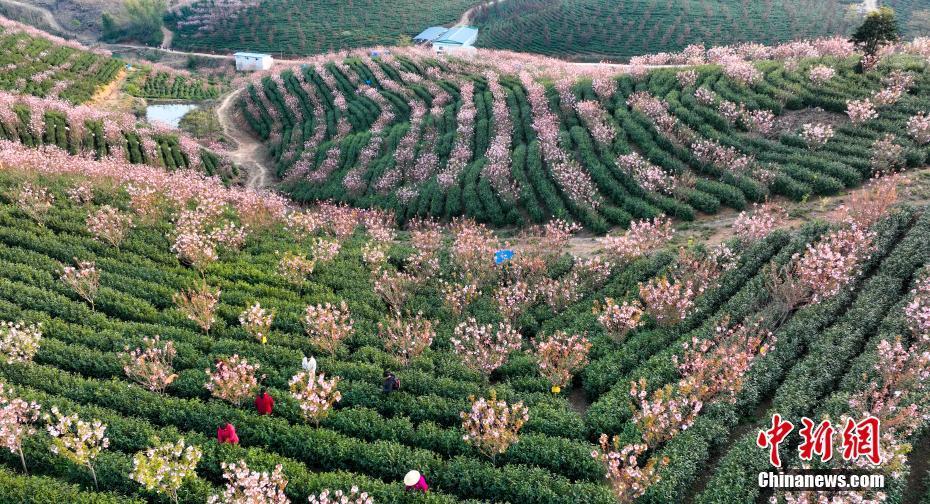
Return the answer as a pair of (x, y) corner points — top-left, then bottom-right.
(207, 460), (291, 504)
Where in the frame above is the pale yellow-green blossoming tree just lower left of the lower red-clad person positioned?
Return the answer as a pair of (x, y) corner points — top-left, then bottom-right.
(129, 438), (203, 504)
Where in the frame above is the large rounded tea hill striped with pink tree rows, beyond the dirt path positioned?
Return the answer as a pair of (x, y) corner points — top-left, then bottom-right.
(234, 42), (930, 232)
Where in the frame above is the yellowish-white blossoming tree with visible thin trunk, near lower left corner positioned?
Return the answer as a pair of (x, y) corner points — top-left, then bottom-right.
(43, 406), (110, 487)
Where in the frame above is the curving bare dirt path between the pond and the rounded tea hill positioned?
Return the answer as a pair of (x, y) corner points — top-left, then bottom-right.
(216, 89), (274, 189)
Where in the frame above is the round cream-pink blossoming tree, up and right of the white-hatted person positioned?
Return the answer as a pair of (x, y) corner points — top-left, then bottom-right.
(450, 317), (522, 377)
